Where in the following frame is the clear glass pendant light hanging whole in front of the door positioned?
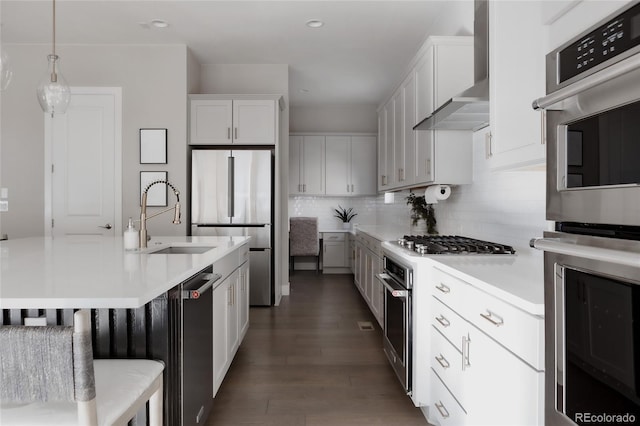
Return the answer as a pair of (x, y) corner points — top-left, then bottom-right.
(37, 0), (71, 117)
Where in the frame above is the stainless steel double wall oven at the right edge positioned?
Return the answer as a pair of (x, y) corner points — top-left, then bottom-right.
(531, 2), (640, 425)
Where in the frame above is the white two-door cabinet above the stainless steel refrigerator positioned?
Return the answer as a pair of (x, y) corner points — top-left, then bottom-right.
(189, 95), (279, 145)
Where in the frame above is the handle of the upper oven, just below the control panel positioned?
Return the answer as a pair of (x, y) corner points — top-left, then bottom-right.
(532, 50), (640, 110)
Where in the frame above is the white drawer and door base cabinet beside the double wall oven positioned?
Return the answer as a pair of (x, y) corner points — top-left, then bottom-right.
(429, 270), (544, 425)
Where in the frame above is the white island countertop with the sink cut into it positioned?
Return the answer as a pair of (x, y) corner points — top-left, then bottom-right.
(0, 236), (250, 309)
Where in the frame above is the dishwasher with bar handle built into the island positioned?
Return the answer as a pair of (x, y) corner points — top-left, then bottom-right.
(182, 266), (222, 426)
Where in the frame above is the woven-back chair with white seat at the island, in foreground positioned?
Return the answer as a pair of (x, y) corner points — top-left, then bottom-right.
(0, 310), (164, 426)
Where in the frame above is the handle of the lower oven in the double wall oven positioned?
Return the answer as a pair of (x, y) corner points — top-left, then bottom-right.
(529, 238), (640, 267)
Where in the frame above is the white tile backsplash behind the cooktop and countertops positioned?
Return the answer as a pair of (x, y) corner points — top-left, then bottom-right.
(289, 132), (547, 247)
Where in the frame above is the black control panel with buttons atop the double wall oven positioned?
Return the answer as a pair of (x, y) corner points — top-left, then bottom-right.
(558, 3), (640, 83)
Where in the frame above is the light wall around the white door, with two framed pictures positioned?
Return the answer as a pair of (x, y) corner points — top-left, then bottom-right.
(0, 45), (187, 238)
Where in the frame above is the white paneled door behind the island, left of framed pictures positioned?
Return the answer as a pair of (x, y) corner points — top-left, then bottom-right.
(45, 88), (122, 237)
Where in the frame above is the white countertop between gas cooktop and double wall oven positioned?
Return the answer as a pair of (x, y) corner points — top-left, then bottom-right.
(382, 242), (544, 316)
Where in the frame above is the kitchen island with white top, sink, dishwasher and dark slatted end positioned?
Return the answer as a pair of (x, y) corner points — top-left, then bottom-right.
(0, 236), (250, 425)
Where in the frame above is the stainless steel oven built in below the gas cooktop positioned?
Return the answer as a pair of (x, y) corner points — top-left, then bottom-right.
(378, 256), (413, 394)
